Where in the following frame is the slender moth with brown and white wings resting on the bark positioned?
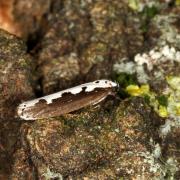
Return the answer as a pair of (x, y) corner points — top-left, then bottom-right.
(17, 80), (118, 120)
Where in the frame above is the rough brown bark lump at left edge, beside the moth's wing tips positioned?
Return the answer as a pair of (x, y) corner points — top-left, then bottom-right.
(0, 30), (33, 120)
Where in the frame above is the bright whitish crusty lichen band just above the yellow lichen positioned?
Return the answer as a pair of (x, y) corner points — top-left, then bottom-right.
(114, 44), (180, 84)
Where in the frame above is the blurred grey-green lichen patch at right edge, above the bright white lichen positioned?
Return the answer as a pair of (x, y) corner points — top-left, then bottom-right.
(147, 13), (180, 49)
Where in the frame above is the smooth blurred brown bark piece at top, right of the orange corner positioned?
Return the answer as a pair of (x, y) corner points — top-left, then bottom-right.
(13, 0), (51, 38)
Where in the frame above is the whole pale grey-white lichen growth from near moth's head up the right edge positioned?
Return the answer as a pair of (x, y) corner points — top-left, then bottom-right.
(114, 12), (180, 84)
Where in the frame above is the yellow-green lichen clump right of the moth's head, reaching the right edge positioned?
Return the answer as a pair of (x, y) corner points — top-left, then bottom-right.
(122, 76), (180, 118)
